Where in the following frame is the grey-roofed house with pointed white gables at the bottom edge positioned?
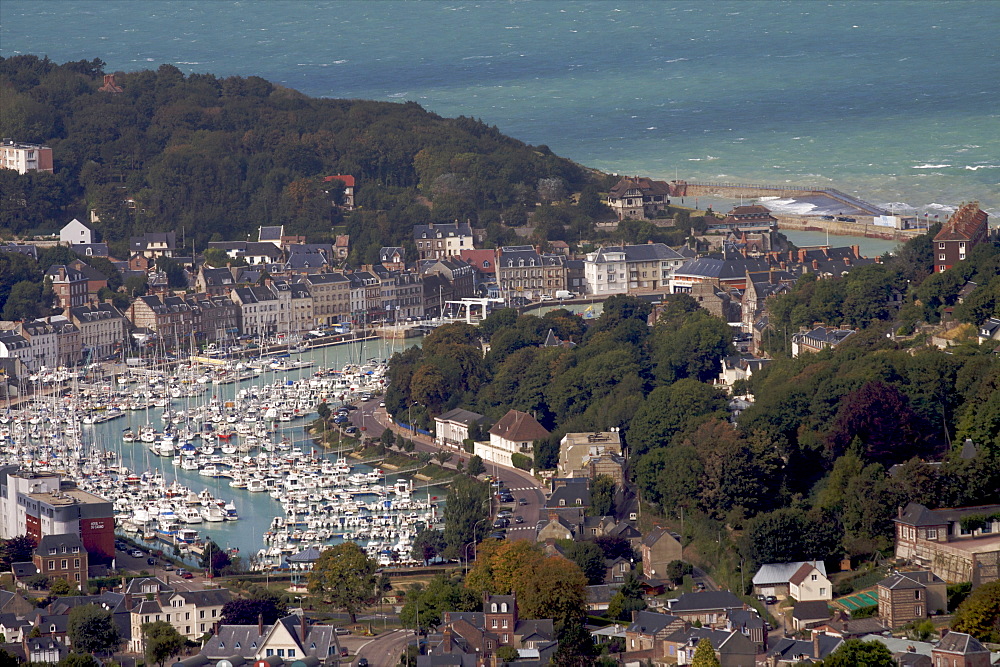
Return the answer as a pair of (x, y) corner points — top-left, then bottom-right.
(201, 615), (340, 667)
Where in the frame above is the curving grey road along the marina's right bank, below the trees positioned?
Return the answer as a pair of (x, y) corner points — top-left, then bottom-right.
(350, 398), (547, 541)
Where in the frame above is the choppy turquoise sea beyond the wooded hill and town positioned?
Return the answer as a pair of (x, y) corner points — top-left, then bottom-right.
(0, 0), (1000, 216)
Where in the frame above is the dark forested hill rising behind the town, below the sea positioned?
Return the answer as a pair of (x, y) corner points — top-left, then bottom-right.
(0, 56), (590, 261)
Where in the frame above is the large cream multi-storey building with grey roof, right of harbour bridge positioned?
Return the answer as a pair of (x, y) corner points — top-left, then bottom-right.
(583, 242), (690, 295)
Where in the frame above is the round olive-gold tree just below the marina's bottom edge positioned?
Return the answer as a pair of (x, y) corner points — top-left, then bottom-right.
(308, 542), (378, 623)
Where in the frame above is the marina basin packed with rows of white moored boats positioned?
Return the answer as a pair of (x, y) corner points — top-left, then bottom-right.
(0, 338), (442, 570)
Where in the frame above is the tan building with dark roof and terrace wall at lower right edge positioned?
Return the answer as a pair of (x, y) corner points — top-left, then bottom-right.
(894, 503), (1000, 588)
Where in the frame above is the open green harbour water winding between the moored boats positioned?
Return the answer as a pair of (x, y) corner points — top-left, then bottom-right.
(83, 338), (423, 558)
